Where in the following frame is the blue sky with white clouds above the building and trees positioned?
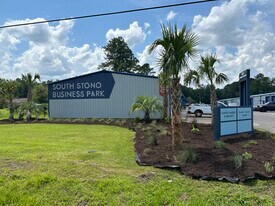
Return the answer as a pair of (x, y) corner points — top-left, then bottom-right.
(0, 0), (275, 85)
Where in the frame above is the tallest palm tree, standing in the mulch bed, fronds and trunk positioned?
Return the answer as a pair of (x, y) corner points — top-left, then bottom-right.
(149, 24), (199, 148)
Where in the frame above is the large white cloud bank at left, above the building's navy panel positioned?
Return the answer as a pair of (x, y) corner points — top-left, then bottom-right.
(0, 18), (104, 80)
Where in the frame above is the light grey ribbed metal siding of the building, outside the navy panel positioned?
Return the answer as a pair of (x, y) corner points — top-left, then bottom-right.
(49, 73), (161, 118)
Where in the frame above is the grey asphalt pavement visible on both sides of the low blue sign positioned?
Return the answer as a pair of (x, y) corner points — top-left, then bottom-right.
(183, 111), (275, 133)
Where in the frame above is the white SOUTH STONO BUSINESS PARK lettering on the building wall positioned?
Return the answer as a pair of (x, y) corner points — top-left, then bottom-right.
(52, 82), (105, 99)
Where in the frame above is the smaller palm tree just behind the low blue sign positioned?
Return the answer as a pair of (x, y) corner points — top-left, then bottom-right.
(184, 54), (228, 125)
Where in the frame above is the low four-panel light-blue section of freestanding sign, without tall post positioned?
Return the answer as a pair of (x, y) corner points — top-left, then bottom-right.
(214, 107), (253, 140)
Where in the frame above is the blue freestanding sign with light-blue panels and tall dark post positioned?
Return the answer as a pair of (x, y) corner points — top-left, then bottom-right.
(214, 69), (253, 141)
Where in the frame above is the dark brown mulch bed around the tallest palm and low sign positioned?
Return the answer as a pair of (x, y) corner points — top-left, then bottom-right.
(135, 123), (275, 182)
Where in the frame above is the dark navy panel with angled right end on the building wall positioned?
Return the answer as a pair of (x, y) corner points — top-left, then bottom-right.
(48, 72), (115, 99)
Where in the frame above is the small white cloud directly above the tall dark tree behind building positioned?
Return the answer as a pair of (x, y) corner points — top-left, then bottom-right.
(106, 21), (148, 48)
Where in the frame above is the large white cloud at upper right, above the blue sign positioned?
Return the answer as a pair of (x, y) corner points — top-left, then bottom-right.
(193, 0), (275, 81)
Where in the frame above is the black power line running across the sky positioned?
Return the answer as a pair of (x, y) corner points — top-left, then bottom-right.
(0, 0), (218, 29)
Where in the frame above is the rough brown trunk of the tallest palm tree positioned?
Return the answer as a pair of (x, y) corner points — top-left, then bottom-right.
(171, 78), (183, 149)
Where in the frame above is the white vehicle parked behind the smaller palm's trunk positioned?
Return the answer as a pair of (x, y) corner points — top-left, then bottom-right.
(188, 102), (227, 117)
